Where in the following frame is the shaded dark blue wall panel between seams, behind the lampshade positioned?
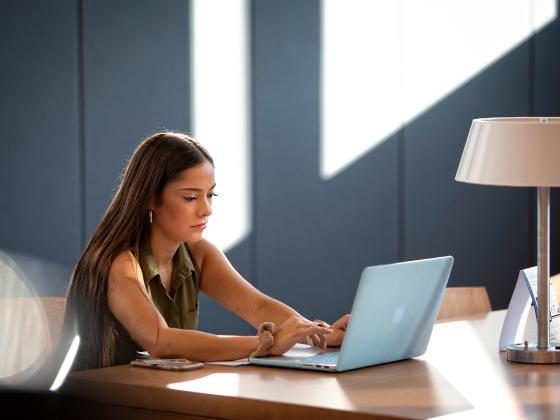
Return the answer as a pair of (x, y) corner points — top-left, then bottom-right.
(403, 44), (534, 308)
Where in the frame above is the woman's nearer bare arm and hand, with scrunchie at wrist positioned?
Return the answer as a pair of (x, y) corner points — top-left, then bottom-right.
(107, 252), (330, 362)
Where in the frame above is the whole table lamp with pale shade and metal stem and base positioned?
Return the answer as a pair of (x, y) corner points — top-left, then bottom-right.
(455, 117), (560, 363)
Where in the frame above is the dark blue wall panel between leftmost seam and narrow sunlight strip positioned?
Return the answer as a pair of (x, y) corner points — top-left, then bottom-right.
(82, 0), (191, 237)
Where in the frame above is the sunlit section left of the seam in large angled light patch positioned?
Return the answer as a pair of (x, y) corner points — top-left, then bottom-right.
(321, 0), (402, 178)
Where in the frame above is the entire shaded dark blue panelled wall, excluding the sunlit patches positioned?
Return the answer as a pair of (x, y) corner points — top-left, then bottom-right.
(0, 0), (560, 333)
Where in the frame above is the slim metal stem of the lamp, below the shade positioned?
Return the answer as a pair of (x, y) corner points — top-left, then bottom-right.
(537, 187), (550, 349)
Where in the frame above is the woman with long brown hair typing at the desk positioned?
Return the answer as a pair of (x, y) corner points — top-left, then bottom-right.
(65, 132), (348, 369)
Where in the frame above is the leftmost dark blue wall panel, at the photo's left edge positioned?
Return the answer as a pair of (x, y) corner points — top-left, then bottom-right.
(0, 0), (83, 295)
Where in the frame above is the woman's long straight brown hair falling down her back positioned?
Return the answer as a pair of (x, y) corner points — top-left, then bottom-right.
(65, 131), (213, 369)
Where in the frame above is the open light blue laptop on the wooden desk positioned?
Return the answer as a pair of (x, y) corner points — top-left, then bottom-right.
(249, 256), (453, 372)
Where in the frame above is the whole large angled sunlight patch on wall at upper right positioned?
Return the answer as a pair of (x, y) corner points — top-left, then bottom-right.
(321, 0), (557, 179)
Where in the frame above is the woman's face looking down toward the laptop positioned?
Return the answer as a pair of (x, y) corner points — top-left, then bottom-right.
(151, 161), (216, 243)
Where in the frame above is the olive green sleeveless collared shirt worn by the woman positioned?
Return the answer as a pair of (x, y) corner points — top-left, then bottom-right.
(115, 244), (200, 364)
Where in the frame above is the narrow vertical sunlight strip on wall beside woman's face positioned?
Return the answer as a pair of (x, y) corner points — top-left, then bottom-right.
(191, 0), (251, 251)
